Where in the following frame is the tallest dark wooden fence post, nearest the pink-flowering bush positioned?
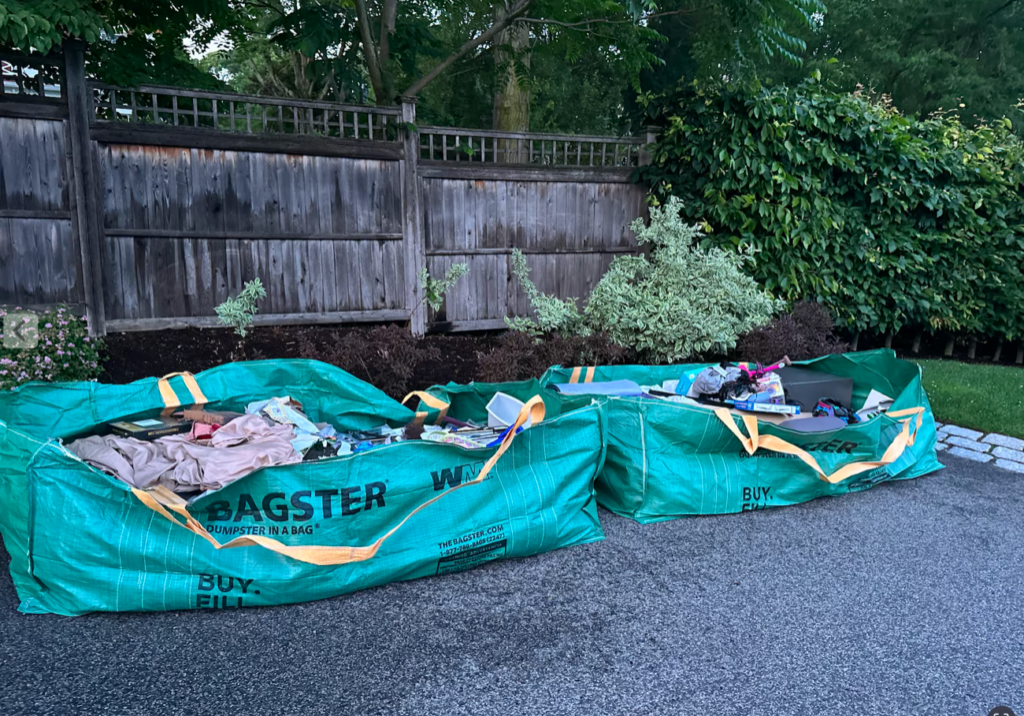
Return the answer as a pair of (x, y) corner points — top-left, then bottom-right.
(63, 40), (106, 336)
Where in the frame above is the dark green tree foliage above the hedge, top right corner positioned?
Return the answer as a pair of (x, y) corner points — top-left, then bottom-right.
(765, 0), (1024, 131)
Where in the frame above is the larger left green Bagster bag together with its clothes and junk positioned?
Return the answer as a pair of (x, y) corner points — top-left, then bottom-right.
(0, 360), (622, 616)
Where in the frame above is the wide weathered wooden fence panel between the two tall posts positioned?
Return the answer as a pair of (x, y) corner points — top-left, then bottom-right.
(97, 144), (406, 321)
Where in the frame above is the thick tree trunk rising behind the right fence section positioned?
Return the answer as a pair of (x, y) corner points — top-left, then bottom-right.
(494, 2), (529, 163)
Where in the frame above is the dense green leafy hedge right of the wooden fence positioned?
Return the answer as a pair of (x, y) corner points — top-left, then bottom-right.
(640, 82), (1024, 339)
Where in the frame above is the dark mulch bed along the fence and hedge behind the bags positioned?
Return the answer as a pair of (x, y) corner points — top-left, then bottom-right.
(99, 325), (1016, 398)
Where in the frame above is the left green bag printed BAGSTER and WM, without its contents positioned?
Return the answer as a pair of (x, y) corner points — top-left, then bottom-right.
(0, 361), (605, 615)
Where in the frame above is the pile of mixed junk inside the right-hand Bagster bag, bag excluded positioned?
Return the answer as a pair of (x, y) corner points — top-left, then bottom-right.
(554, 356), (893, 432)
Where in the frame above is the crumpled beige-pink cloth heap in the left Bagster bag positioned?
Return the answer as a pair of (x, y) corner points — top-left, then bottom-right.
(68, 415), (302, 492)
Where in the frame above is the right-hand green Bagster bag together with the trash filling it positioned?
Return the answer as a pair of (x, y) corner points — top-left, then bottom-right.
(540, 350), (940, 523)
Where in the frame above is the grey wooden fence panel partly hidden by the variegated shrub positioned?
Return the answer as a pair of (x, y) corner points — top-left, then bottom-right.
(423, 178), (646, 323)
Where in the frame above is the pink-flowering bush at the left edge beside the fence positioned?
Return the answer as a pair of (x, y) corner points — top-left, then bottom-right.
(0, 306), (102, 390)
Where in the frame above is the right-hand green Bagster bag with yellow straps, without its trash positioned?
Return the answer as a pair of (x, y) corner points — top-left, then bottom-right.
(541, 350), (942, 522)
